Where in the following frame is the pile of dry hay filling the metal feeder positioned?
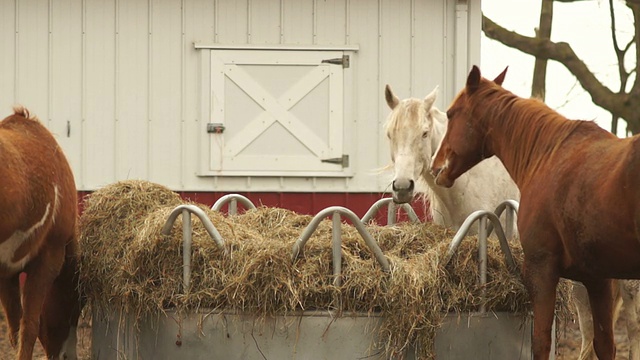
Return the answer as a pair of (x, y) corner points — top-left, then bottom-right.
(81, 182), (569, 358)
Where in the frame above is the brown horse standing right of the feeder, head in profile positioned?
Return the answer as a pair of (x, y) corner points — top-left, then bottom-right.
(432, 66), (640, 359)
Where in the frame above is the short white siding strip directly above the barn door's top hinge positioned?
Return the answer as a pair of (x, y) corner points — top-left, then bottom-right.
(315, 0), (346, 45)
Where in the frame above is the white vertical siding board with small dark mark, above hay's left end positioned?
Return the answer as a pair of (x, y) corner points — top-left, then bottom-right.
(49, 0), (82, 183)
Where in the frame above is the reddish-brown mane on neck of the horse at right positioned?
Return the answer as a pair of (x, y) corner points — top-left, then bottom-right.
(472, 80), (610, 184)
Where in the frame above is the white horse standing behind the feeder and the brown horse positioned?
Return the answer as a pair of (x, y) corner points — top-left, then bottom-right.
(385, 85), (640, 360)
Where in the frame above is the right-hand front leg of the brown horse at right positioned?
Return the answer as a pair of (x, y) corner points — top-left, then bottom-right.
(583, 279), (616, 360)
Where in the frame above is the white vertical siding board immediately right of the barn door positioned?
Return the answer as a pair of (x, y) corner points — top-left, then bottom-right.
(345, 0), (382, 188)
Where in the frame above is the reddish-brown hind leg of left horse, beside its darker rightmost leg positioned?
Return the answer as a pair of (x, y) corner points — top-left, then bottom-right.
(18, 246), (64, 360)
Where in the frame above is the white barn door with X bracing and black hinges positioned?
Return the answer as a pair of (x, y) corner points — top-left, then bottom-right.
(207, 50), (349, 176)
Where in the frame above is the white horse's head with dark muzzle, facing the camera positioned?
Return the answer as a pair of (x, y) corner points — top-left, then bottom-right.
(385, 85), (446, 203)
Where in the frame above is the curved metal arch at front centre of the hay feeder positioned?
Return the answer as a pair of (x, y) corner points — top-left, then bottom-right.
(291, 206), (389, 276)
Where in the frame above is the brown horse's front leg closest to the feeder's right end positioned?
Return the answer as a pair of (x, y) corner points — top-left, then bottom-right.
(523, 253), (560, 360)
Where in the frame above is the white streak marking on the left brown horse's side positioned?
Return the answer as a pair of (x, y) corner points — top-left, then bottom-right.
(0, 186), (59, 271)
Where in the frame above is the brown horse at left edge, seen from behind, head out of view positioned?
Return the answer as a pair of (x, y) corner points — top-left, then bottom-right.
(0, 107), (80, 360)
